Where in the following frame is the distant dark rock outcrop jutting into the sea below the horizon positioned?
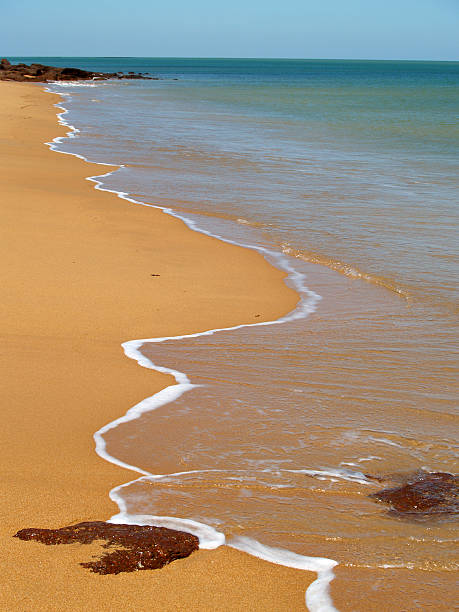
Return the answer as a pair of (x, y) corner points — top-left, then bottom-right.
(0, 58), (157, 83)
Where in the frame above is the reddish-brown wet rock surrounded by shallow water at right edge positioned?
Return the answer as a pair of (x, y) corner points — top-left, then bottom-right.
(369, 470), (459, 519)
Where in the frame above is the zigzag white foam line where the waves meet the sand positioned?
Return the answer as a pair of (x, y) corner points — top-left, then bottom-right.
(45, 83), (337, 612)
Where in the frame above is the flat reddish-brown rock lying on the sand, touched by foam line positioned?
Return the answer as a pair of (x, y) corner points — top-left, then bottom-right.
(14, 521), (199, 574)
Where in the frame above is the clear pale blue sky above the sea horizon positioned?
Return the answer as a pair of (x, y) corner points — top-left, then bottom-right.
(0, 0), (459, 60)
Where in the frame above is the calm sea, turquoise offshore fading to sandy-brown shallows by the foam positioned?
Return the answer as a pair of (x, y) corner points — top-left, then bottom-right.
(21, 58), (459, 596)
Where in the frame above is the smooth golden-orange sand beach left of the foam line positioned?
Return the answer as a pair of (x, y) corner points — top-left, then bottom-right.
(2, 83), (324, 610)
